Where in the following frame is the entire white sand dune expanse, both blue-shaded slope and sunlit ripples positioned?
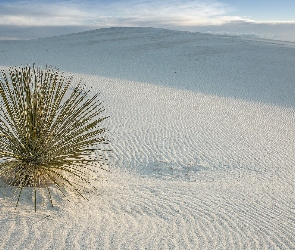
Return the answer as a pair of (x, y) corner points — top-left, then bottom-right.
(0, 28), (295, 250)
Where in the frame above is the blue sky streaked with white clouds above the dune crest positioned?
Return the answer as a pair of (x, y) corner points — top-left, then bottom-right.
(0, 0), (295, 42)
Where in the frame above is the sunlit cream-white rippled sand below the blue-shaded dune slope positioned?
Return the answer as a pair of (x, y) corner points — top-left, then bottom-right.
(0, 76), (295, 250)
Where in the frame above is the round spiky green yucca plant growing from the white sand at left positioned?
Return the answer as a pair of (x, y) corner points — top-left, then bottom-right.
(0, 65), (108, 211)
